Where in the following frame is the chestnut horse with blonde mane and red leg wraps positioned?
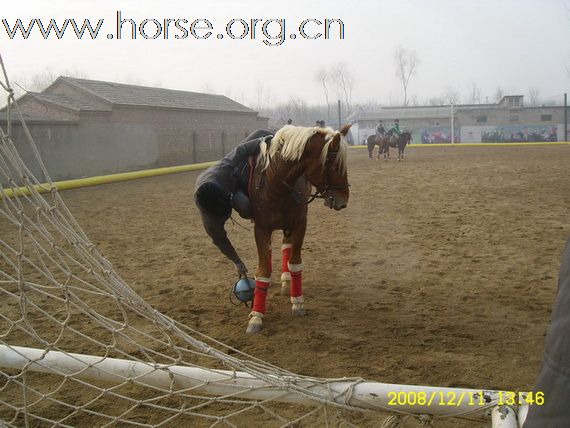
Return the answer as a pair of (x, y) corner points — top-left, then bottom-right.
(247, 125), (350, 333)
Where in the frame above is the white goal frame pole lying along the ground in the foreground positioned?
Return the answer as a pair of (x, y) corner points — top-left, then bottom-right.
(0, 345), (528, 428)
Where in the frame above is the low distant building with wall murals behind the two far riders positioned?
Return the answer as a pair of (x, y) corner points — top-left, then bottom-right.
(349, 95), (570, 144)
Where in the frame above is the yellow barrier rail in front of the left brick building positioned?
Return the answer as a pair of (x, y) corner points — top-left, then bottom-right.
(0, 162), (216, 198)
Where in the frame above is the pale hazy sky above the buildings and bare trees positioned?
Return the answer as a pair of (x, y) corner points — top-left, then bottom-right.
(0, 0), (570, 106)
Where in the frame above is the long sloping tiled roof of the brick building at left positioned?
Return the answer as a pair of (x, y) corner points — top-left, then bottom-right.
(58, 76), (254, 113)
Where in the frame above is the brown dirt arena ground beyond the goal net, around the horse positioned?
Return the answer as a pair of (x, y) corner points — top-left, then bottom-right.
(4, 146), (570, 426)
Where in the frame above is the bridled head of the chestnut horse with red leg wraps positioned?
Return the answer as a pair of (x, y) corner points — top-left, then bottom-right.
(301, 125), (351, 211)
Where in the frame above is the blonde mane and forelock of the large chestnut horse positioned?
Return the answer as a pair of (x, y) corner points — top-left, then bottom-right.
(257, 125), (348, 172)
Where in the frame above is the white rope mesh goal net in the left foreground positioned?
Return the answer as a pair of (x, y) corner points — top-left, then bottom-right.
(0, 59), (492, 427)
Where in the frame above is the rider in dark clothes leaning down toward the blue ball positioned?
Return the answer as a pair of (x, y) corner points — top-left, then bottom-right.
(194, 130), (272, 277)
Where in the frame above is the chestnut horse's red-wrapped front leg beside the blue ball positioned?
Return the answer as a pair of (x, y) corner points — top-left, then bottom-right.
(246, 224), (271, 333)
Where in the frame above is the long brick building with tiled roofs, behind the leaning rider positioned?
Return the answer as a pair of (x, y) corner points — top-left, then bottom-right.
(0, 77), (268, 180)
